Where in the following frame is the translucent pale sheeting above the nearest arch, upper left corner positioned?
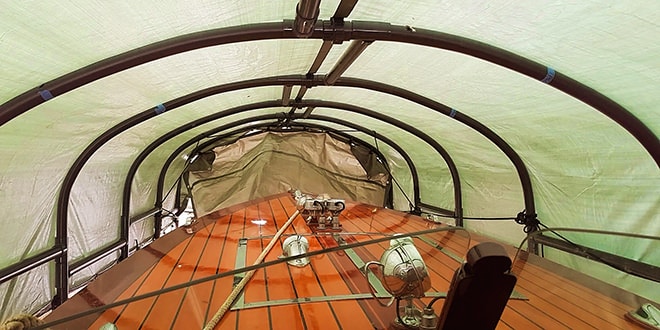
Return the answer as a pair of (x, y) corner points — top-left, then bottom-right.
(0, 0), (337, 103)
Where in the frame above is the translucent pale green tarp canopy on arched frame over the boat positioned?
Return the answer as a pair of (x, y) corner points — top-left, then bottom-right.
(0, 0), (660, 319)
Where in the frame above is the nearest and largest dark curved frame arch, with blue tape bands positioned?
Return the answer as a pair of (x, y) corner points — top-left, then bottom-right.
(0, 20), (660, 165)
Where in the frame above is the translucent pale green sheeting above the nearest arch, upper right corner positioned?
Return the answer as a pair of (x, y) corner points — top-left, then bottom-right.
(350, 0), (660, 134)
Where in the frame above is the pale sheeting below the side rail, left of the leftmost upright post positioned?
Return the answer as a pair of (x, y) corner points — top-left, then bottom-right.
(0, 262), (55, 321)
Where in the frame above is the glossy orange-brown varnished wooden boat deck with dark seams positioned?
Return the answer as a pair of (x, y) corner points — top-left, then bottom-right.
(46, 195), (641, 330)
